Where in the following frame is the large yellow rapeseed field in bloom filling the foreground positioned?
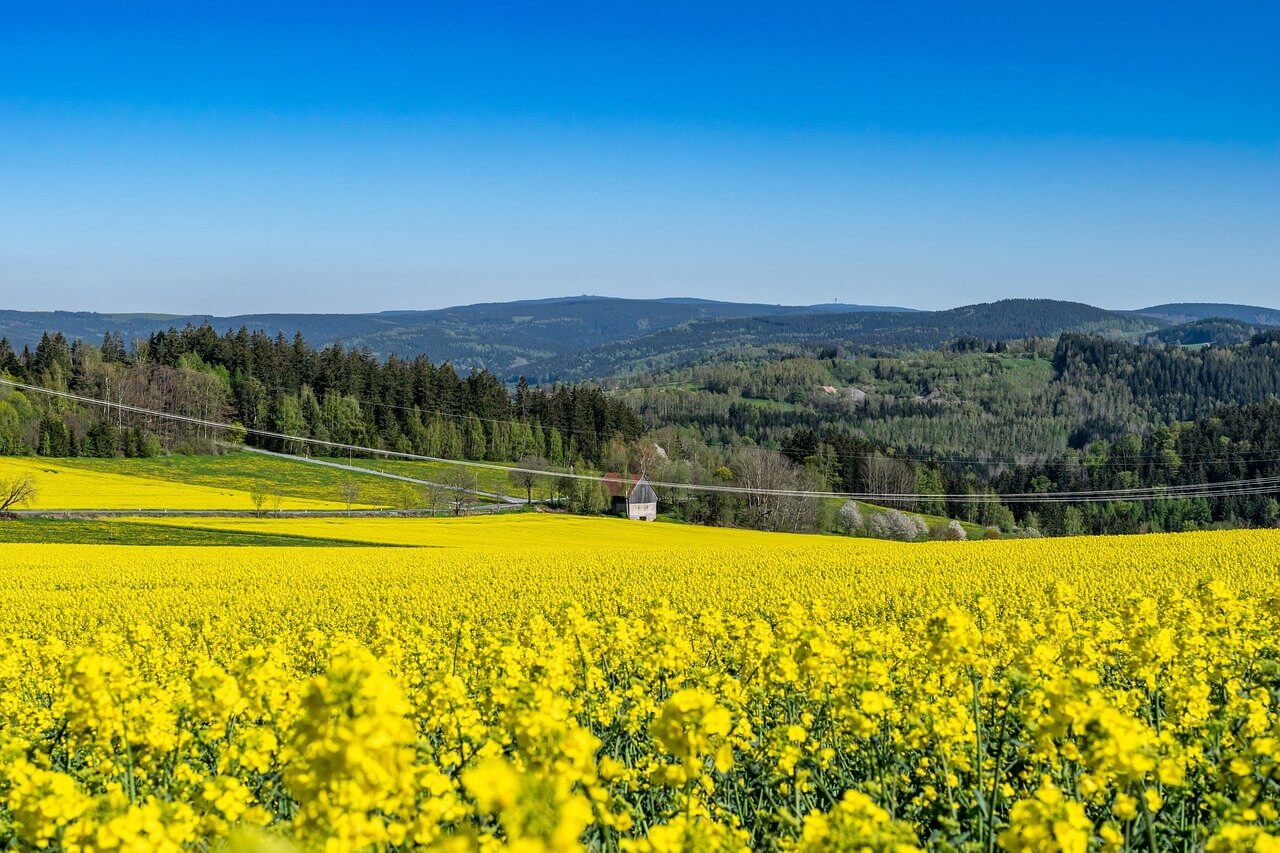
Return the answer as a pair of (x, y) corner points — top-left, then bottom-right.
(0, 515), (1280, 850)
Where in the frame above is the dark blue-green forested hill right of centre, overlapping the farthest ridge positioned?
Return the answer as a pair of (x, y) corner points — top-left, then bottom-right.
(522, 300), (1164, 380)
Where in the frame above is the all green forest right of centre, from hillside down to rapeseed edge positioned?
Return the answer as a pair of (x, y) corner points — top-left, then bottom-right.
(612, 330), (1280, 534)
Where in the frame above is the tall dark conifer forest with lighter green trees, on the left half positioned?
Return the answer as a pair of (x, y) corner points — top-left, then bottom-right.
(0, 324), (643, 465)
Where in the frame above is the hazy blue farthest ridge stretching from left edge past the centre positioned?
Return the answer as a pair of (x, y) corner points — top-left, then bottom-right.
(0, 296), (909, 375)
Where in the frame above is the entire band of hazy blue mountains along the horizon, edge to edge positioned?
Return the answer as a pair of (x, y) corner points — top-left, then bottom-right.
(0, 296), (1280, 382)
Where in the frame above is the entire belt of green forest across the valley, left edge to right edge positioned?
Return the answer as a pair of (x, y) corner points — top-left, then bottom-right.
(0, 324), (1280, 535)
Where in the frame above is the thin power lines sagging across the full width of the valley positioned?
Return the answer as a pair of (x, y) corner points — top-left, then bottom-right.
(0, 378), (1280, 503)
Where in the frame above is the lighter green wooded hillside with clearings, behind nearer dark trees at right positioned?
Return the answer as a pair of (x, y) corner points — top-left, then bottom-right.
(608, 330), (1280, 464)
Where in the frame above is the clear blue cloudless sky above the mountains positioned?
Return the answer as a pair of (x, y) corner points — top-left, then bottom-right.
(0, 0), (1280, 314)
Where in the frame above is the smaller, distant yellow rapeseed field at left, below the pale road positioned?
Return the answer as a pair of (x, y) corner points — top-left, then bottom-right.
(0, 456), (343, 510)
